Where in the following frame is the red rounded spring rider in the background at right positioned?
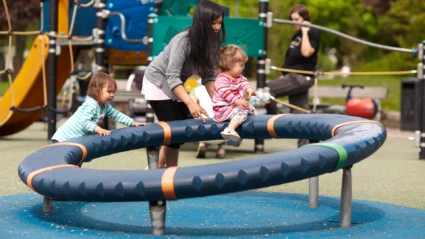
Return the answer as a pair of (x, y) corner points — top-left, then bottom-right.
(341, 84), (379, 119)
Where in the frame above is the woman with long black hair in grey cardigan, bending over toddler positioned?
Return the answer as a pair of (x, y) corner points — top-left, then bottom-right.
(142, 0), (226, 168)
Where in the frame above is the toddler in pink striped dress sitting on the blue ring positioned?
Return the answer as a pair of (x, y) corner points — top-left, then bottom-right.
(212, 44), (257, 142)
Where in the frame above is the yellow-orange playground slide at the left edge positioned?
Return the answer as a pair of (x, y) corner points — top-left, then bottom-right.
(0, 35), (71, 136)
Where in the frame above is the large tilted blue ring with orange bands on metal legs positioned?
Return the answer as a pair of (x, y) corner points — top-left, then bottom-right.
(19, 114), (386, 235)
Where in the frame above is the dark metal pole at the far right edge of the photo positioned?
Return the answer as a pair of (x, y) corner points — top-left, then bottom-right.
(418, 41), (425, 159)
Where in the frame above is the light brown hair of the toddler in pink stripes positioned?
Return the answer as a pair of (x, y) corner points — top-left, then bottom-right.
(218, 44), (248, 71)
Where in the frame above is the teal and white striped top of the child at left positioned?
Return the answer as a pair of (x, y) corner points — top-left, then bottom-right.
(52, 96), (133, 142)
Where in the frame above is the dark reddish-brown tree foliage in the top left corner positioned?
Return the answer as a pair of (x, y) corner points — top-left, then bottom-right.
(0, 0), (40, 77)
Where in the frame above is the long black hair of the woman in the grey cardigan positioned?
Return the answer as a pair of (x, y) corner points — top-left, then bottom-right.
(188, 0), (226, 74)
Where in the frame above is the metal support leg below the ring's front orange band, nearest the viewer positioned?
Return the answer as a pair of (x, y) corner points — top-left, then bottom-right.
(146, 146), (167, 236)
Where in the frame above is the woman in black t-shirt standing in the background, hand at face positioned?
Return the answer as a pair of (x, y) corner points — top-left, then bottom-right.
(267, 4), (320, 146)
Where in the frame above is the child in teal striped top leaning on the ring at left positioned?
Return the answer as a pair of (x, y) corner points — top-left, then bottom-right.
(52, 72), (146, 143)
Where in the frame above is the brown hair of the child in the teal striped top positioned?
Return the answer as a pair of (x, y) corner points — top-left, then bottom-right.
(87, 72), (117, 102)
